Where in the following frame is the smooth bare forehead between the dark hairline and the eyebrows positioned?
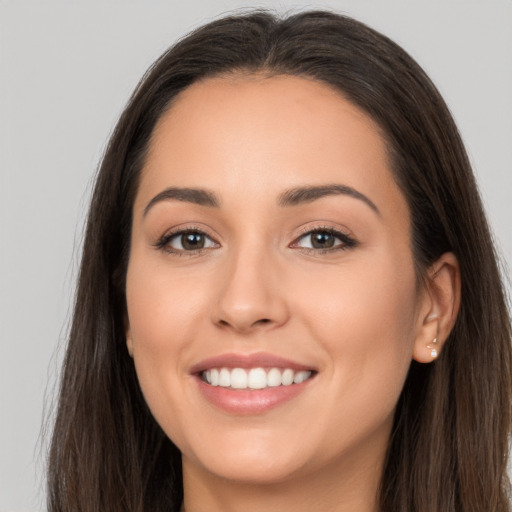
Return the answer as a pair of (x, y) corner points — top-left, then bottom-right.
(140, 75), (404, 222)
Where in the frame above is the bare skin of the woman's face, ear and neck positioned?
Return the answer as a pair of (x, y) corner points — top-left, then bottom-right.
(126, 75), (459, 512)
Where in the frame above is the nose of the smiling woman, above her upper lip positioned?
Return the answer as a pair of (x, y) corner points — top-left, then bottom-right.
(212, 249), (289, 334)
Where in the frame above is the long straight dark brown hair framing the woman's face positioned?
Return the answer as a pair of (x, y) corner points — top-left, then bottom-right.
(48, 11), (511, 512)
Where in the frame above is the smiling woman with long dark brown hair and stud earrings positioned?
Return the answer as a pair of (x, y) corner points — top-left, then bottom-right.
(49, 12), (511, 512)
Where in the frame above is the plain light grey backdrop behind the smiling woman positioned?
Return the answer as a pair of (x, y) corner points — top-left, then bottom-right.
(0, 0), (512, 512)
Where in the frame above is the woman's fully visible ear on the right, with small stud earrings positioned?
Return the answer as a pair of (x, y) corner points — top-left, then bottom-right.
(413, 252), (460, 363)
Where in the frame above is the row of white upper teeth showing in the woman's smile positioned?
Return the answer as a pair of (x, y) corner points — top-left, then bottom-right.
(202, 368), (312, 389)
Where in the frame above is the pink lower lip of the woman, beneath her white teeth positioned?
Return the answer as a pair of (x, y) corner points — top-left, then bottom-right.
(196, 377), (312, 415)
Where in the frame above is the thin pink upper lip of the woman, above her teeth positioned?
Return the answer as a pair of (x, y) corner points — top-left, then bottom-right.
(190, 352), (314, 374)
